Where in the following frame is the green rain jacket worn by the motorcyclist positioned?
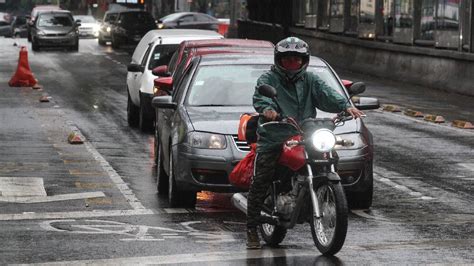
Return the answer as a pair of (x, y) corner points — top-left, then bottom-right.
(253, 66), (351, 152)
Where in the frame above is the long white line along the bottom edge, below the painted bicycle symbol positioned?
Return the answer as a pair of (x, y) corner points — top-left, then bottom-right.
(29, 249), (318, 265)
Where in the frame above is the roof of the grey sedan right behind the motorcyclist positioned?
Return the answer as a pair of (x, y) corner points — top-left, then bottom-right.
(200, 53), (328, 67)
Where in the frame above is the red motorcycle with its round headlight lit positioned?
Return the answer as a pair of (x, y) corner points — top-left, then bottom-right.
(232, 84), (354, 255)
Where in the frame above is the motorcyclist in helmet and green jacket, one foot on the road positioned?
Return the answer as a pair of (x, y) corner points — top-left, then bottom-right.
(247, 37), (363, 249)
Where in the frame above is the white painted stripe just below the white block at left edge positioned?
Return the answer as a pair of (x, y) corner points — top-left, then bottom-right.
(0, 191), (105, 203)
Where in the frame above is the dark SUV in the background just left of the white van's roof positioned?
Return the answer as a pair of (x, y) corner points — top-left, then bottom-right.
(110, 11), (157, 48)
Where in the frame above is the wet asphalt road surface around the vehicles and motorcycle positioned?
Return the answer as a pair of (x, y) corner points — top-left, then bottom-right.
(0, 38), (474, 265)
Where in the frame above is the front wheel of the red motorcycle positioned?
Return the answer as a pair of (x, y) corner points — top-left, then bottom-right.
(310, 181), (348, 255)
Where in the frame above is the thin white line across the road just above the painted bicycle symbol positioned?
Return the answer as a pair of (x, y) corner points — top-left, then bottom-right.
(0, 209), (154, 221)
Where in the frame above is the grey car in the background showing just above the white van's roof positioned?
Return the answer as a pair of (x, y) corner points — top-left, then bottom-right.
(158, 12), (219, 31)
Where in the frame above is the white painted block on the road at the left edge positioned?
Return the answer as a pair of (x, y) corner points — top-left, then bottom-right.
(0, 177), (46, 197)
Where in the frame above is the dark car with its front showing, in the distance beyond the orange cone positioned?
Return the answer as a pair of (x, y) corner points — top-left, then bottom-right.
(31, 10), (81, 51)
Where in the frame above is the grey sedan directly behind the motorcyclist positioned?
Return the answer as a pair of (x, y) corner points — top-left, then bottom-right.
(152, 53), (378, 207)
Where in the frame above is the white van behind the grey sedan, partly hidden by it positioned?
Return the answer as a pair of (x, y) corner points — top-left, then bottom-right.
(127, 29), (224, 131)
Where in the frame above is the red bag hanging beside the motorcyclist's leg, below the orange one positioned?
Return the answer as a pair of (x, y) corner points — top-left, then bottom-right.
(229, 143), (257, 190)
